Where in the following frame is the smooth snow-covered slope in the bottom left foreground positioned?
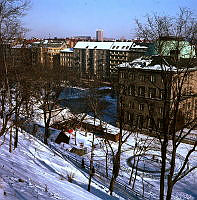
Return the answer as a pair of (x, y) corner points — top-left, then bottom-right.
(0, 133), (107, 200)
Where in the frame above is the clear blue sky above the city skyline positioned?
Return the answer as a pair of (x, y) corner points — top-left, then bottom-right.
(24, 0), (197, 39)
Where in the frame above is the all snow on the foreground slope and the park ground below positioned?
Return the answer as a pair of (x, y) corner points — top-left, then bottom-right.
(0, 89), (197, 200)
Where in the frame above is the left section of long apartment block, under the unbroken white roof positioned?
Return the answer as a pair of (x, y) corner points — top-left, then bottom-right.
(74, 42), (113, 80)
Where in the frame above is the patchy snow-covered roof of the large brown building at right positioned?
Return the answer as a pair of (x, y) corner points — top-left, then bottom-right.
(117, 58), (177, 71)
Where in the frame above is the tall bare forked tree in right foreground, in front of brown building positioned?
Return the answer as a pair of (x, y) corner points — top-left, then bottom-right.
(136, 9), (197, 200)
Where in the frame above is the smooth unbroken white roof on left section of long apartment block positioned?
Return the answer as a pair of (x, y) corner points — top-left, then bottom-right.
(74, 41), (113, 49)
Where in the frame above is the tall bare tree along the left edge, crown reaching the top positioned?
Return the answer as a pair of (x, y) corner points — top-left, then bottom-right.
(0, 0), (30, 145)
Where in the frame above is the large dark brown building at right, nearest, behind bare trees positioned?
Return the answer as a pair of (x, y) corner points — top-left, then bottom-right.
(117, 58), (197, 130)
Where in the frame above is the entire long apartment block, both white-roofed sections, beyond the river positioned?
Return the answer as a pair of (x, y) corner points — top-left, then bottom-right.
(74, 42), (147, 81)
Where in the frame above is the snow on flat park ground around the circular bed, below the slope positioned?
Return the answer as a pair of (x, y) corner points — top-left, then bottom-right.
(55, 126), (197, 200)
